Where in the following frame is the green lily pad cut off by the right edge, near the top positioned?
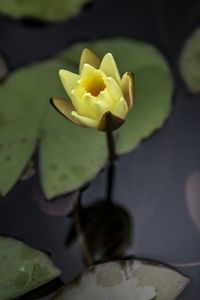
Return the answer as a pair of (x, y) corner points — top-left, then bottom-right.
(179, 28), (200, 94)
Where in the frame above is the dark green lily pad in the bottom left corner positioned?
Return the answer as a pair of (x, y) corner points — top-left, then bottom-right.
(0, 237), (61, 300)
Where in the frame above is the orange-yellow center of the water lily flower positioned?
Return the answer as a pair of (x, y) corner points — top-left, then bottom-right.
(82, 73), (106, 97)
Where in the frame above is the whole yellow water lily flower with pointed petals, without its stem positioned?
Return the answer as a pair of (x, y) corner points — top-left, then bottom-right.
(51, 48), (134, 131)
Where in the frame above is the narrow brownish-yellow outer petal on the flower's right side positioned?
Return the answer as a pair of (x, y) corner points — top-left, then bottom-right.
(121, 72), (135, 109)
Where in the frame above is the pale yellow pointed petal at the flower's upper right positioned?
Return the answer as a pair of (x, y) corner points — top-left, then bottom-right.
(100, 53), (121, 83)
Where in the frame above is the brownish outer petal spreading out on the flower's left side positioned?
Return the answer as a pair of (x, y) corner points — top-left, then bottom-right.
(50, 98), (81, 126)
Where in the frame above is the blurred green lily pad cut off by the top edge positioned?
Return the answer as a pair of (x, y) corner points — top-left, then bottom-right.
(0, 0), (91, 21)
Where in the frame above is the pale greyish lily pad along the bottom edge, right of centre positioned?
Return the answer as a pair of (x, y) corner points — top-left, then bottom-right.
(53, 260), (189, 300)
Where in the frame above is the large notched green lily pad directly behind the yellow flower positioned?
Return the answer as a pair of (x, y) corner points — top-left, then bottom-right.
(0, 39), (173, 199)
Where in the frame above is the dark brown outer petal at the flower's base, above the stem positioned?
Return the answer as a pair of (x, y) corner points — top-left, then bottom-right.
(97, 111), (125, 131)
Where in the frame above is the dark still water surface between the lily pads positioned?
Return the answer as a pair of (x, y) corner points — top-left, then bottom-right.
(0, 0), (200, 300)
